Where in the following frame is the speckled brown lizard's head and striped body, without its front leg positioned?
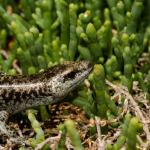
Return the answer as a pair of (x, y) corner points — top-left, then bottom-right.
(0, 61), (92, 115)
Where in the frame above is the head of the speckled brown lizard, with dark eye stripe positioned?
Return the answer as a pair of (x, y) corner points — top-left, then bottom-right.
(49, 61), (93, 98)
